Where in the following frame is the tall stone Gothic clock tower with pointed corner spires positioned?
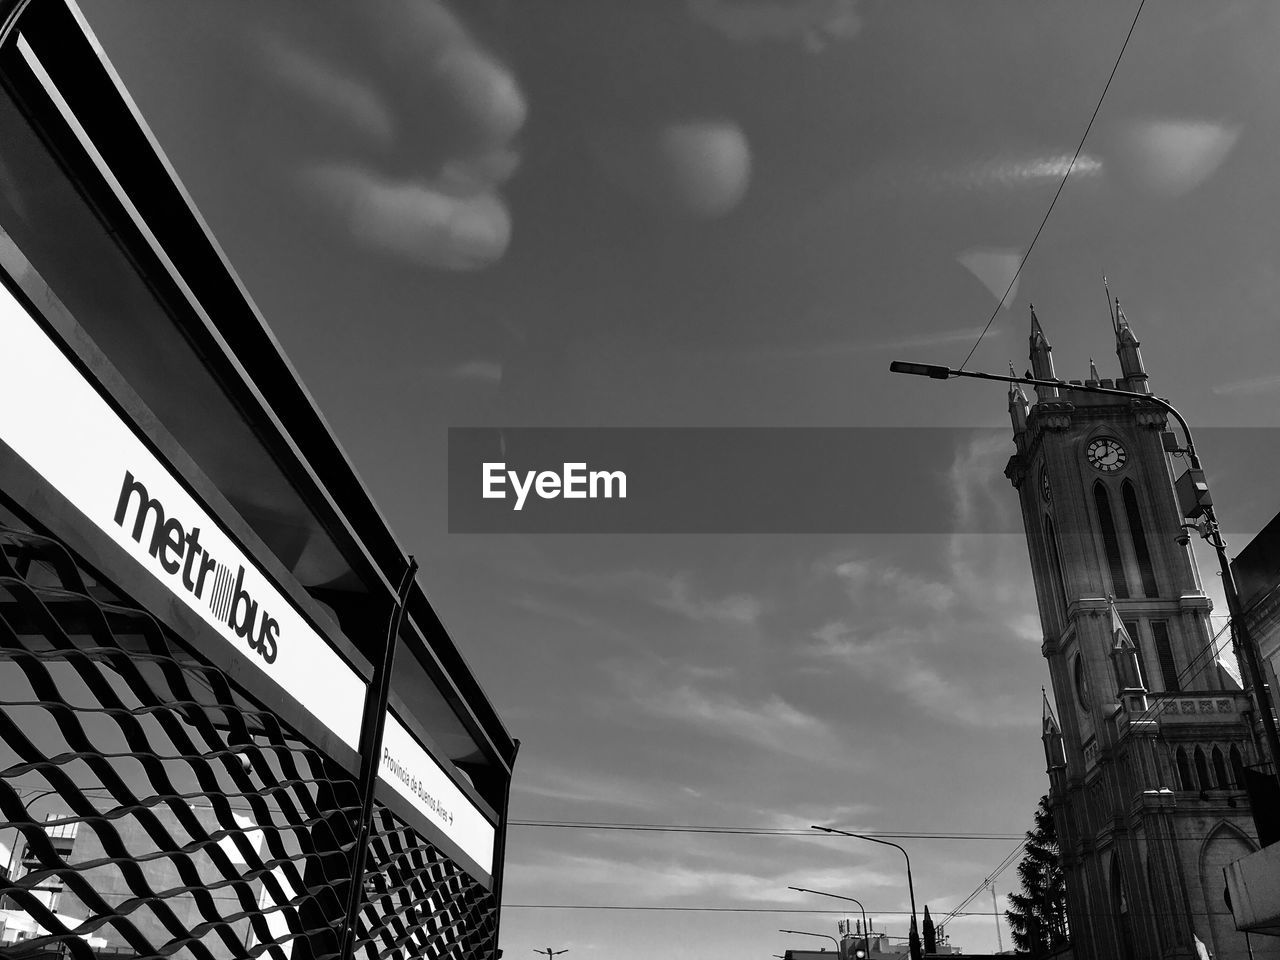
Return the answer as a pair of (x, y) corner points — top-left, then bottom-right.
(1005, 302), (1280, 960)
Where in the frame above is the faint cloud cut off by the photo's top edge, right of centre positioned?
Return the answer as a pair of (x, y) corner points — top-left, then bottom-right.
(687, 0), (863, 52)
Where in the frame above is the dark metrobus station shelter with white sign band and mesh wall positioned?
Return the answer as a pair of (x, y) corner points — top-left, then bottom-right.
(0, 0), (516, 960)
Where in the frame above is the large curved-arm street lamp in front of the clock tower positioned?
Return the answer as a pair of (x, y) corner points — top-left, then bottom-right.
(888, 360), (1280, 781)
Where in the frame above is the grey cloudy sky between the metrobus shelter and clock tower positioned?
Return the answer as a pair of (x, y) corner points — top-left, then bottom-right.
(67, 0), (1280, 960)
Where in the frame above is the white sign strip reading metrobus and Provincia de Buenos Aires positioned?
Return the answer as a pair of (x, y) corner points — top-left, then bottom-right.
(0, 285), (494, 873)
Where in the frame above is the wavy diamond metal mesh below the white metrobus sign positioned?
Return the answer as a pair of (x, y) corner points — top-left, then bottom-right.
(0, 526), (497, 960)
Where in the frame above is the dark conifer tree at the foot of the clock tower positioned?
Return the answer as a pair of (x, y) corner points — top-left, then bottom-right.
(1005, 796), (1070, 956)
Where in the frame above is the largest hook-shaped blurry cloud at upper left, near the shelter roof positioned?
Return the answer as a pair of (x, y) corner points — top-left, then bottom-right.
(242, 0), (527, 270)
